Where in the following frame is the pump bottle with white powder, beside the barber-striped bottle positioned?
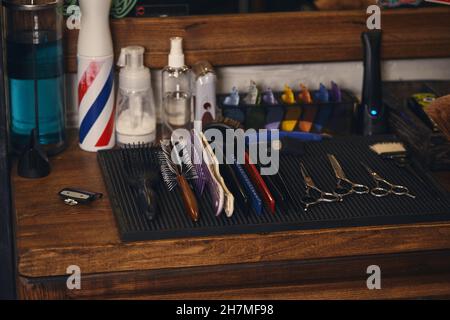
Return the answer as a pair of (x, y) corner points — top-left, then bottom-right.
(116, 46), (156, 146)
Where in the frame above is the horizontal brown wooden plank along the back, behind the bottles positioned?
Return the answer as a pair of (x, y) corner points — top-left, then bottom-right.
(66, 7), (450, 72)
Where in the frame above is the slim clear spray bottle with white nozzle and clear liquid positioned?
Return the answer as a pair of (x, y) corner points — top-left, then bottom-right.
(162, 37), (192, 138)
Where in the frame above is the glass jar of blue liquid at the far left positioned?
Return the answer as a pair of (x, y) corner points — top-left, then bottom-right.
(4, 1), (65, 154)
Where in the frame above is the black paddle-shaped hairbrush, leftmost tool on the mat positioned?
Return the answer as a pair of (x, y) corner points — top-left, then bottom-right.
(121, 144), (159, 220)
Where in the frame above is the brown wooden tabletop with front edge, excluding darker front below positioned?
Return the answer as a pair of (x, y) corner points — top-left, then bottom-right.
(13, 131), (450, 277)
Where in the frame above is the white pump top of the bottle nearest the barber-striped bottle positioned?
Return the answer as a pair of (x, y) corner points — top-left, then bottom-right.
(117, 46), (151, 91)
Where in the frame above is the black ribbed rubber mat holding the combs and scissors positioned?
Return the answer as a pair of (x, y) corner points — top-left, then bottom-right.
(98, 136), (450, 241)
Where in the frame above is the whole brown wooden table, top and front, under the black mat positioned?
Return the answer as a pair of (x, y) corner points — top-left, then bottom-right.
(13, 132), (450, 299)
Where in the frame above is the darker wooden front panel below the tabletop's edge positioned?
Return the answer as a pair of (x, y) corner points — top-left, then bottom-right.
(15, 251), (450, 299)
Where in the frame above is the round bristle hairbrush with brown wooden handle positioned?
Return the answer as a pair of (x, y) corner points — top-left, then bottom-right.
(158, 140), (200, 221)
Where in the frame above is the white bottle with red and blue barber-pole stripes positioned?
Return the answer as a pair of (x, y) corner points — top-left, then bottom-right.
(78, 0), (116, 152)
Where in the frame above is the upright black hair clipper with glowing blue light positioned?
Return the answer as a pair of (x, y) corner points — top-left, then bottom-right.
(357, 30), (387, 136)
